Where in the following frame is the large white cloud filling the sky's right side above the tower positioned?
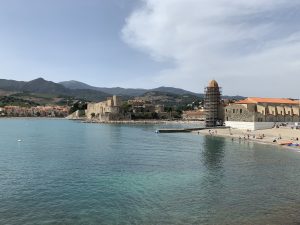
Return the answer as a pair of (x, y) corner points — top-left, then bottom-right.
(122, 0), (300, 97)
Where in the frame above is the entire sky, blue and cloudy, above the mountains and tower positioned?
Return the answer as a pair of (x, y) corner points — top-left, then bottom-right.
(0, 0), (300, 98)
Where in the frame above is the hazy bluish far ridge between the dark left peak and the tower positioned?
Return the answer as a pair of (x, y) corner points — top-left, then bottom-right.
(60, 80), (202, 97)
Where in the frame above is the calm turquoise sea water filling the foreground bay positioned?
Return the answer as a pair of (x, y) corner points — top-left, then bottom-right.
(0, 119), (300, 225)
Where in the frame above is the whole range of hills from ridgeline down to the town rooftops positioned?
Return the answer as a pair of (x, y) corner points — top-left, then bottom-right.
(0, 78), (242, 111)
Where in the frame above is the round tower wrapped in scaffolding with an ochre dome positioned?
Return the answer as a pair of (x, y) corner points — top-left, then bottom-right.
(204, 80), (222, 127)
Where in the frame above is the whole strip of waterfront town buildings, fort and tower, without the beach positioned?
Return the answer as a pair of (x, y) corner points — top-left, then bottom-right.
(0, 80), (300, 134)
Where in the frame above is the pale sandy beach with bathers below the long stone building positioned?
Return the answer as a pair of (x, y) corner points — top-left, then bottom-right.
(194, 127), (300, 151)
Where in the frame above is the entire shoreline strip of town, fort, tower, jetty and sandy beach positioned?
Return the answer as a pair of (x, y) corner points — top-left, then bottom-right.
(0, 80), (300, 148)
